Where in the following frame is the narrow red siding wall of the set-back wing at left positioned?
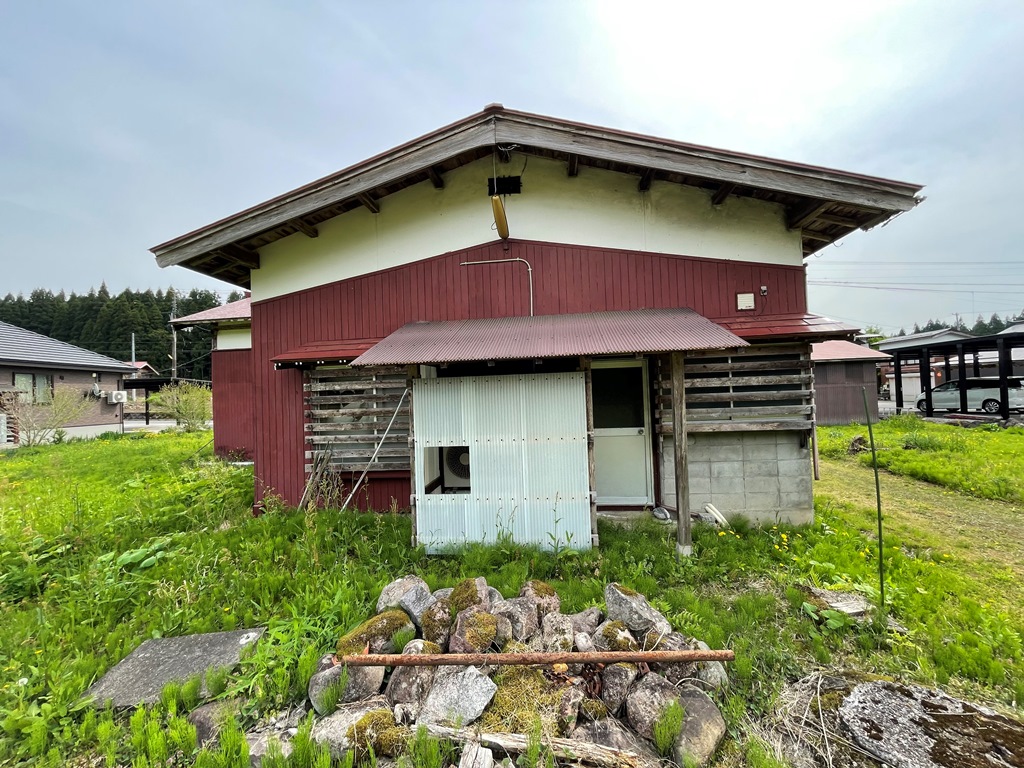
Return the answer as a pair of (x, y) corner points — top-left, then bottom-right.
(210, 349), (256, 459)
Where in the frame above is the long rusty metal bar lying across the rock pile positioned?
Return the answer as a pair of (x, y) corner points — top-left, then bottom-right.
(337, 650), (736, 667)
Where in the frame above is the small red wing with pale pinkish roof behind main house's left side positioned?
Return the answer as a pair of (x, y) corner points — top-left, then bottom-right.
(171, 297), (256, 459)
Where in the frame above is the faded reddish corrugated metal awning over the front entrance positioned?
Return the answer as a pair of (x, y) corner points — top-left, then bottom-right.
(352, 308), (748, 366)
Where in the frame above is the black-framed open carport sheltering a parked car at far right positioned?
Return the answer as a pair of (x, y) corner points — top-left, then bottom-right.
(892, 332), (1024, 419)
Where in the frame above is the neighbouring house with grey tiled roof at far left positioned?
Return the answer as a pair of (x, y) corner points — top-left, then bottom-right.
(0, 323), (133, 443)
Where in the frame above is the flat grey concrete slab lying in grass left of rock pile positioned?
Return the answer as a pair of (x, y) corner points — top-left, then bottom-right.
(85, 627), (266, 709)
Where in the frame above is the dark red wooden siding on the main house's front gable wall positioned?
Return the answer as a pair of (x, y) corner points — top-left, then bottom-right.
(249, 242), (806, 507)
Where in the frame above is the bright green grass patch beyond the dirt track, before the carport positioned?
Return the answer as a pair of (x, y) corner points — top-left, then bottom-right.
(818, 414), (1024, 503)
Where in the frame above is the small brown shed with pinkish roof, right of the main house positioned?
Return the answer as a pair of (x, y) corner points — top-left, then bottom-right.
(811, 341), (891, 424)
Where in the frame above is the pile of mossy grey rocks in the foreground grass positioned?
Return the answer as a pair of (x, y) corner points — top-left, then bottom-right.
(292, 575), (727, 768)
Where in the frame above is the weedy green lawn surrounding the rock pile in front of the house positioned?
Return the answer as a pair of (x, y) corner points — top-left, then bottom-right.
(0, 428), (1024, 768)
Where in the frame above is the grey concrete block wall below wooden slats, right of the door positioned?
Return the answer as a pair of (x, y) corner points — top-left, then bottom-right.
(660, 431), (814, 524)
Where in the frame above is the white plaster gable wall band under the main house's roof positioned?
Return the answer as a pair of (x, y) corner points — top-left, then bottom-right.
(252, 154), (803, 301)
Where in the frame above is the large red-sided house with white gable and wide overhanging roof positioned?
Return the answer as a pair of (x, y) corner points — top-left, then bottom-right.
(153, 105), (921, 549)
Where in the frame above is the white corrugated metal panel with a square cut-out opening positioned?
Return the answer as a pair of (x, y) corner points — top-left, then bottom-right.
(413, 373), (591, 552)
